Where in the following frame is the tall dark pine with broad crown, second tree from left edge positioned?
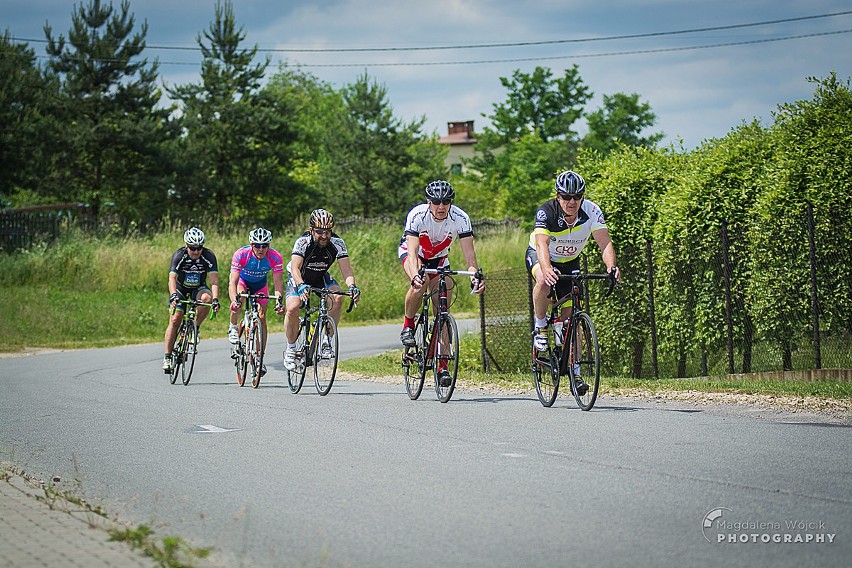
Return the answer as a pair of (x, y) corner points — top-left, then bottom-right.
(44, 0), (170, 219)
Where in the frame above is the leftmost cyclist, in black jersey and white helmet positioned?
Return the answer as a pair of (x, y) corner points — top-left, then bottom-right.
(163, 227), (219, 373)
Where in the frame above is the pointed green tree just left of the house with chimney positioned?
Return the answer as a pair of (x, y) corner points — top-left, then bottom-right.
(312, 72), (447, 217)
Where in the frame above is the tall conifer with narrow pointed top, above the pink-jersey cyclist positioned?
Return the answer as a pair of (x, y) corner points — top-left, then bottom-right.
(169, 1), (292, 221)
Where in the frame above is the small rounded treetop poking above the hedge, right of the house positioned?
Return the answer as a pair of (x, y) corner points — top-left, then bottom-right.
(583, 93), (663, 154)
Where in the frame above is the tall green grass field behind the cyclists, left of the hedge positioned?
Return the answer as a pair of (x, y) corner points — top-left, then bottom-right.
(0, 225), (526, 352)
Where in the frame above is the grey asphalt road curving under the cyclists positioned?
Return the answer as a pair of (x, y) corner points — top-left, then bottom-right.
(0, 325), (852, 568)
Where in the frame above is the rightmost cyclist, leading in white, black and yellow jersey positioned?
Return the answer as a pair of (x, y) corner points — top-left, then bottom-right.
(526, 170), (621, 390)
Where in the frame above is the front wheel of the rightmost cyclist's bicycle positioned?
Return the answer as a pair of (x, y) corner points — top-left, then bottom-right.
(567, 312), (601, 410)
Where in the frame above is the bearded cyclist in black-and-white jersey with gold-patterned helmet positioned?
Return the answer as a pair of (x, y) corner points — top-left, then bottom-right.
(284, 209), (361, 371)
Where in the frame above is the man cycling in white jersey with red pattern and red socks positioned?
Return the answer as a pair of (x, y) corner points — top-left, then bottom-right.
(399, 180), (485, 382)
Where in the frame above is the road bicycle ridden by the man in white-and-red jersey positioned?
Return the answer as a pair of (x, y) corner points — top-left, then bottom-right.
(402, 267), (484, 402)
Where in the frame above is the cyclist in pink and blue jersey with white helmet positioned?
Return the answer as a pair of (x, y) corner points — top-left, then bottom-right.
(228, 227), (284, 375)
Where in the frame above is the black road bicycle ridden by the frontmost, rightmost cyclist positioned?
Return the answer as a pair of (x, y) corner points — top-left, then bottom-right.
(532, 272), (615, 410)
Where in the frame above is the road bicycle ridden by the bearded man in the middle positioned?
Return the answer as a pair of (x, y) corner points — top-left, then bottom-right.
(285, 286), (356, 396)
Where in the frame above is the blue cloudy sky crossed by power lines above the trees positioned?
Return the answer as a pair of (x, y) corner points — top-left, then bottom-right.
(6, 0), (852, 149)
